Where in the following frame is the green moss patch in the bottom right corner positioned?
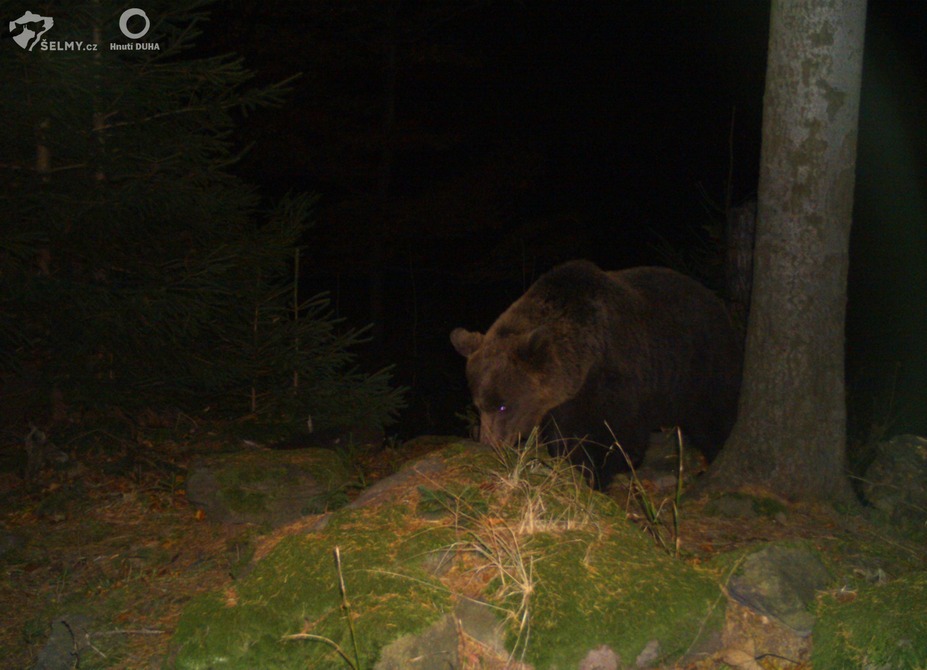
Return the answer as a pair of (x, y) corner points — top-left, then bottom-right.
(812, 572), (927, 670)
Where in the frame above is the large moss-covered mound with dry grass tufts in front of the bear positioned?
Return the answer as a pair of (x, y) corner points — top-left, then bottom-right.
(168, 443), (724, 670)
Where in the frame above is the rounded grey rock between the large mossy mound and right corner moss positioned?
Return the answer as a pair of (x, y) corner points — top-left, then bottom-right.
(728, 545), (832, 637)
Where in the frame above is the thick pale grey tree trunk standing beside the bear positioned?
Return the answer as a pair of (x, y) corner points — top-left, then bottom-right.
(705, 0), (866, 500)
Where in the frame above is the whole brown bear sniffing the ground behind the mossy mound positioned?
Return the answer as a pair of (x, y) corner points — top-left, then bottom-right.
(451, 261), (741, 489)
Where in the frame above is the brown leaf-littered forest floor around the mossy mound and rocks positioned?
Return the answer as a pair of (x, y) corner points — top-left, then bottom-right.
(0, 433), (927, 670)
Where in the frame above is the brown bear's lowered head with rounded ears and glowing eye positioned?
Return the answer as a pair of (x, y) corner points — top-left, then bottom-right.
(451, 326), (568, 444)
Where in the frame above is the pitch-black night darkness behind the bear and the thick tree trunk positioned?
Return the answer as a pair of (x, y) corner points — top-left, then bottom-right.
(203, 5), (927, 439)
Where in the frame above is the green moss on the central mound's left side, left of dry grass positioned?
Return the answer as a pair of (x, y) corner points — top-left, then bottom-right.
(172, 507), (450, 670)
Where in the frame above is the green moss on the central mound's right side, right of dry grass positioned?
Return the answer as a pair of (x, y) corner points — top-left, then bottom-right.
(492, 525), (724, 668)
